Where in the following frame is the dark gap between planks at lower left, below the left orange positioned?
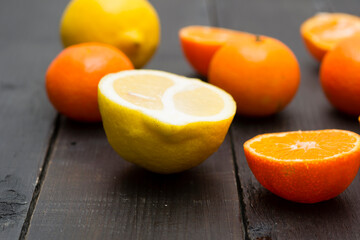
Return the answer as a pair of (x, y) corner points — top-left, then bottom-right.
(19, 114), (60, 240)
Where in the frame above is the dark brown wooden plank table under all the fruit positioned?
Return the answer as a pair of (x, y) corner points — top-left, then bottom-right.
(0, 0), (360, 240)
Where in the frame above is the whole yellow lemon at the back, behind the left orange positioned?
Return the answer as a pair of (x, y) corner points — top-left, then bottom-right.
(60, 0), (160, 68)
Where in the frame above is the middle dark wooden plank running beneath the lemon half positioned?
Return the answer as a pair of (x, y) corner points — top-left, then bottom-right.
(27, 0), (244, 240)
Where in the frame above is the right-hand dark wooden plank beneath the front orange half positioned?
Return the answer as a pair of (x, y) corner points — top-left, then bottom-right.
(217, 0), (360, 239)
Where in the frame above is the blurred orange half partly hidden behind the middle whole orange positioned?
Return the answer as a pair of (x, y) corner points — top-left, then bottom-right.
(179, 26), (250, 76)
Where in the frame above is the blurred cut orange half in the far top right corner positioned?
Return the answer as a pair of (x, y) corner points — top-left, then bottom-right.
(300, 13), (360, 61)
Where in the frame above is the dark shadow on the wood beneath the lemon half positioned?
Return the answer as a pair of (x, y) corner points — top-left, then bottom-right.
(111, 165), (221, 202)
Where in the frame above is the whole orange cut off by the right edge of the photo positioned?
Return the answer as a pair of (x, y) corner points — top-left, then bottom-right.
(320, 36), (360, 115)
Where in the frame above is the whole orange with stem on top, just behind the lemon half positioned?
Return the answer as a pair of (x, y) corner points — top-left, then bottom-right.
(209, 35), (300, 116)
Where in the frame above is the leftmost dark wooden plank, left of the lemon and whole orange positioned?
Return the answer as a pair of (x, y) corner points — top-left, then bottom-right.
(0, 0), (65, 239)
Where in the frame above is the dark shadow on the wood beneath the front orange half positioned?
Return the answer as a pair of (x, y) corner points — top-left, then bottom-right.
(244, 187), (354, 239)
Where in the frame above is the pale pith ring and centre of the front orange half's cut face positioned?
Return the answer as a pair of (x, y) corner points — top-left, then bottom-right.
(245, 129), (360, 162)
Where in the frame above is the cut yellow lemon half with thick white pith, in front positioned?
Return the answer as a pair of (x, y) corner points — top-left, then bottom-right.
(98, 70), (236, 174)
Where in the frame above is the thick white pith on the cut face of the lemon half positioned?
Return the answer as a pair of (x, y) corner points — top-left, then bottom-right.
(99, 70), (236, 125)
